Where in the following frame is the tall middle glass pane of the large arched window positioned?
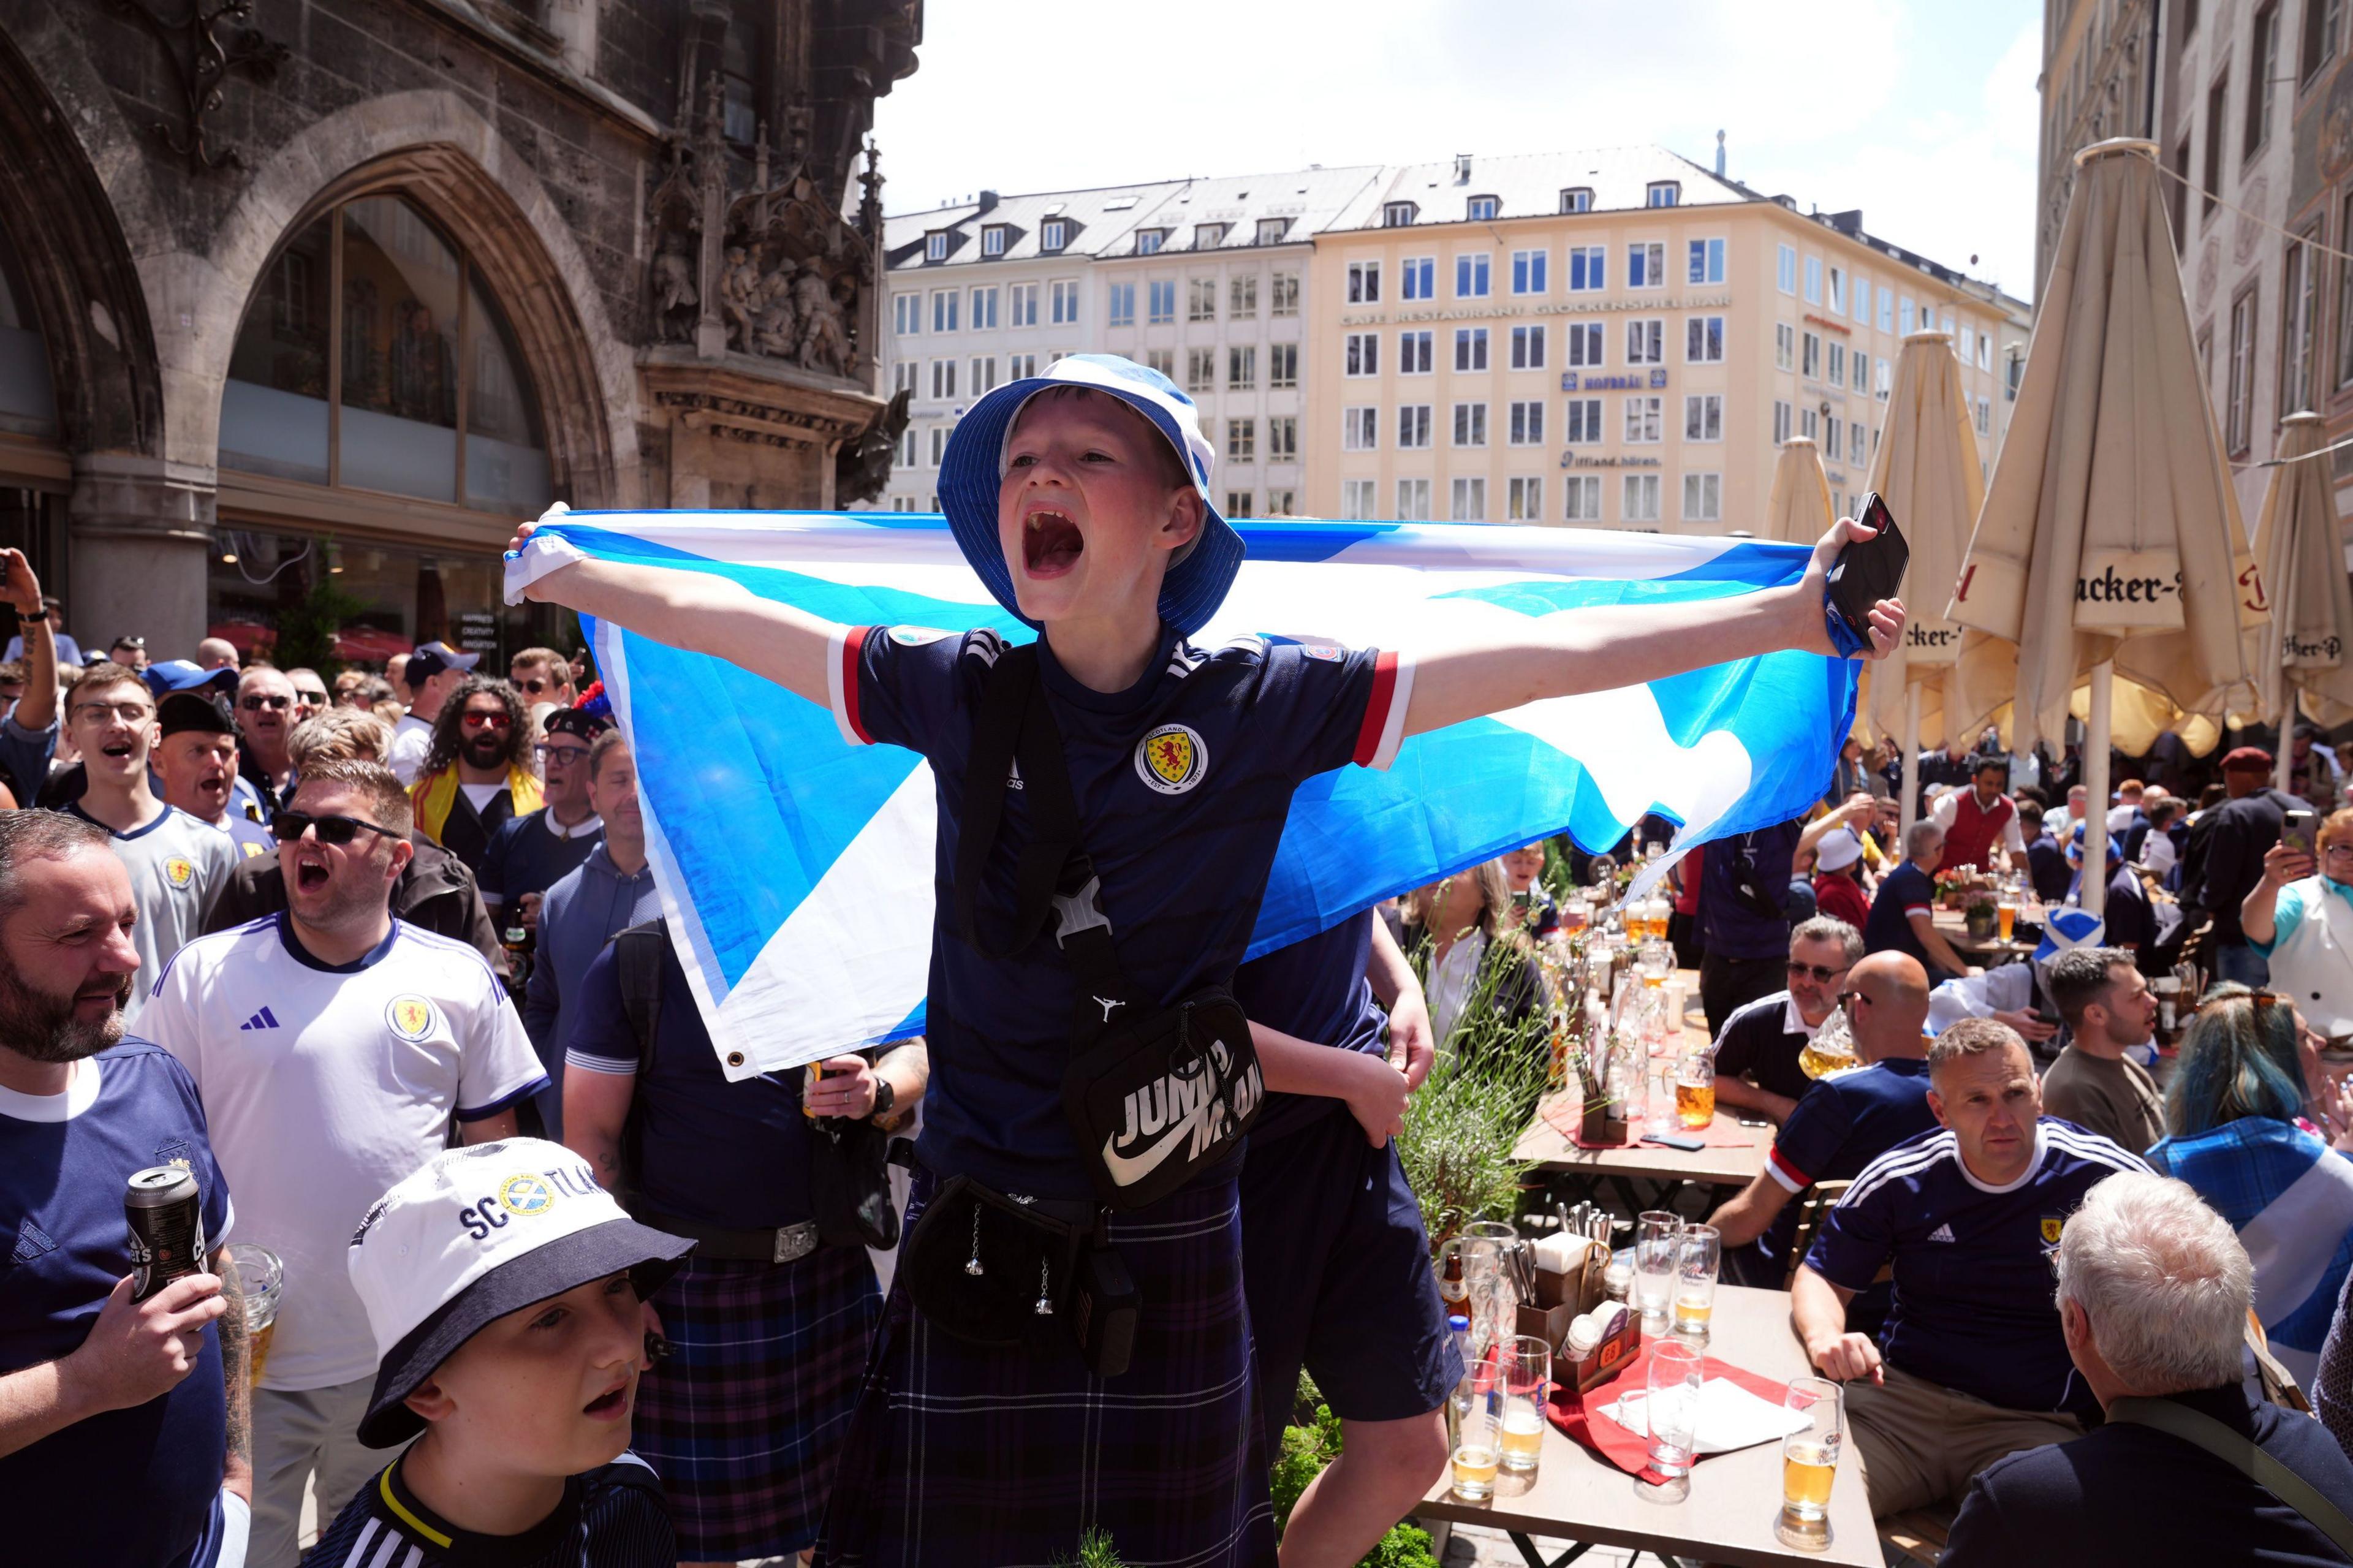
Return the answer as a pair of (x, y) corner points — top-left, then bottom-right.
(341, 195), (459, 501)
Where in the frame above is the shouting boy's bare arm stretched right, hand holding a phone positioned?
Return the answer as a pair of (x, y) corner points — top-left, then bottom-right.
(1404, 518), (1904, 735)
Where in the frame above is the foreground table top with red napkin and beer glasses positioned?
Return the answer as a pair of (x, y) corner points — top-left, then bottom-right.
(1414, 1286), (1882, 1568)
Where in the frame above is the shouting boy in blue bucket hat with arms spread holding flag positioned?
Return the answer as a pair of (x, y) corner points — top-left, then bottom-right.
(515, 353), (1904, 1568)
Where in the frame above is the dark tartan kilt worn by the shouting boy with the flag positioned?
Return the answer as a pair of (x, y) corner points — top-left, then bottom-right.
(816, 1168), (1275, 1568)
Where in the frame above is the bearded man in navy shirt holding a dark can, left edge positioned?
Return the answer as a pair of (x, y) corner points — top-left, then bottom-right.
(0, 812), (252, 1568)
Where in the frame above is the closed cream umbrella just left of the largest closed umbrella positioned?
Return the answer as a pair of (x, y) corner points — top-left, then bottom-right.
(1871, 332), (1986, 833)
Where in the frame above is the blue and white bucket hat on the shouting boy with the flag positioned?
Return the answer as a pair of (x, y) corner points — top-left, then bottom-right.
(939, 353), (1243, 635)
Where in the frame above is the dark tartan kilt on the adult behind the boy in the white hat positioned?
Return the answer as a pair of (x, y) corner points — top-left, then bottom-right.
(631, 1248), (880, 1563)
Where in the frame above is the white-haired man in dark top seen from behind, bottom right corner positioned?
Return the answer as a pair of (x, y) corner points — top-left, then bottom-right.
(1944, 1175), (2353, 1568)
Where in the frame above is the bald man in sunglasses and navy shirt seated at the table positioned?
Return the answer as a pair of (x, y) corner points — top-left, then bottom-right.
(1708, 953), (1936, 1333)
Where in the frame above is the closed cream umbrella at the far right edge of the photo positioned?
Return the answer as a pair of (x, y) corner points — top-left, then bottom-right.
(2254, 414), (2353, 789)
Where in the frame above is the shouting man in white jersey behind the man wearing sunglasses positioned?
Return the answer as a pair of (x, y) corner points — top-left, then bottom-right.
(66, 664), (238, 1022)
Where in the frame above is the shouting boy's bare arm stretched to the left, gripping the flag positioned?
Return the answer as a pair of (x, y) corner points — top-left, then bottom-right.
(506, 523), (840, 706)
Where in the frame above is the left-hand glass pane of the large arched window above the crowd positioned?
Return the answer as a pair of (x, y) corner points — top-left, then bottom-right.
(221, 219), (330, 485)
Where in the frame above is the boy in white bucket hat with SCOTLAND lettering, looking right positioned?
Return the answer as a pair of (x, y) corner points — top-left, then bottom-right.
(308, 1137), (694, 1568)
